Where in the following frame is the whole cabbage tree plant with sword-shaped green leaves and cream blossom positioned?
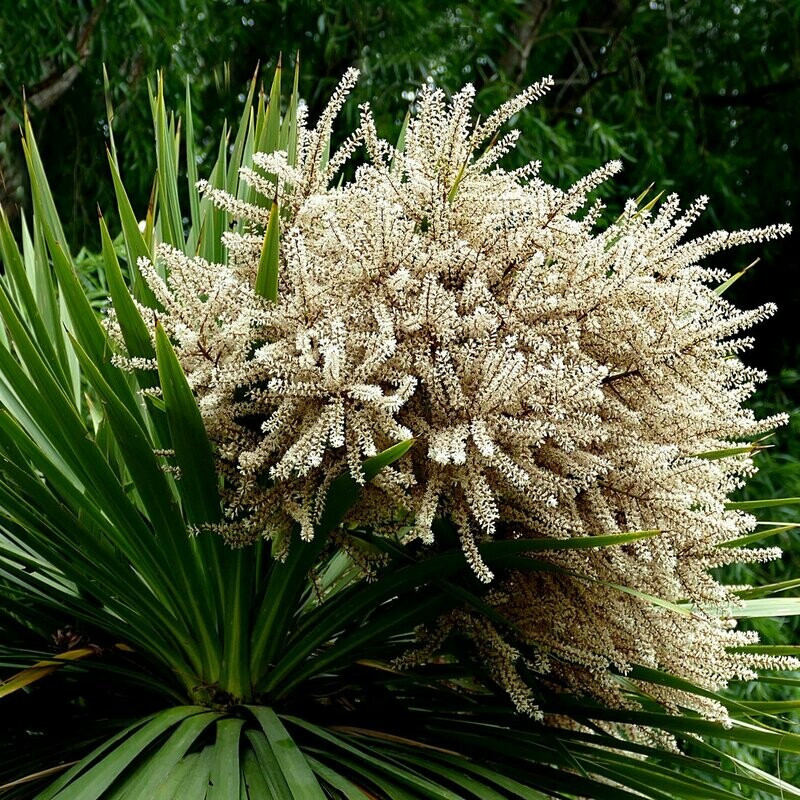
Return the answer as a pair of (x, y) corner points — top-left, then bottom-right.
(0, 67), (800, 800)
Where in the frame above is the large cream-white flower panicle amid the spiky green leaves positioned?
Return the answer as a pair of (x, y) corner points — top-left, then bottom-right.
(104, 71), (793, 732)
